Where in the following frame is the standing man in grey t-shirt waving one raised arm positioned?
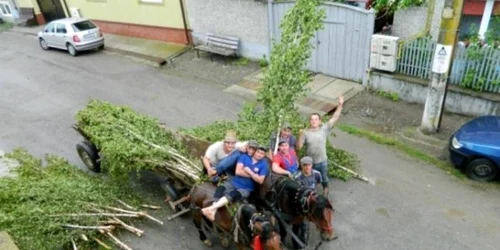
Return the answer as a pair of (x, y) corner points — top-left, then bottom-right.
(297, 96), (344, 195)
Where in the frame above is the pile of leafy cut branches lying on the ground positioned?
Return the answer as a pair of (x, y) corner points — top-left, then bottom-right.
(0, 149), (163, 250)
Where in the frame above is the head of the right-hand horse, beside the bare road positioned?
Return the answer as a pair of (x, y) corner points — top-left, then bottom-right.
(305, 191), (335, 241)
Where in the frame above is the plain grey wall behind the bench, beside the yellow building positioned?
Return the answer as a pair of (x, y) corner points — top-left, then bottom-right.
(186, 0), (269, 59)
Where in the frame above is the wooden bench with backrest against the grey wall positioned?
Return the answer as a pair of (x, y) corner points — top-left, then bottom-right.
(195, 33), (240, 62)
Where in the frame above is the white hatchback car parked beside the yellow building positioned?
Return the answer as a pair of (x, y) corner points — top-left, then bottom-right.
(38, 17), (104, 56)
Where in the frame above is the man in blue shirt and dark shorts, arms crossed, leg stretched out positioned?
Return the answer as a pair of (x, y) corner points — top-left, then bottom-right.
(202, 145), (269, 221)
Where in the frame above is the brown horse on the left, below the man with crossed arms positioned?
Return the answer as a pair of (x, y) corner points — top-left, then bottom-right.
(190, 183), (282, 250)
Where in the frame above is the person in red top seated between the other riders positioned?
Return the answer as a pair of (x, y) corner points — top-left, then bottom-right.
(272, 139), (299, 178)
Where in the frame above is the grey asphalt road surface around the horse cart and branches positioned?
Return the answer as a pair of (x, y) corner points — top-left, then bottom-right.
(0, 33), (500, 250)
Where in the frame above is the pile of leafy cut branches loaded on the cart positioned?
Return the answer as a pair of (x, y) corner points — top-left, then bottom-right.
(76, 100), (203, 186)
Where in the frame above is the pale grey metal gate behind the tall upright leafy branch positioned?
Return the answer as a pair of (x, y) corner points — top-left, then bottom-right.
(268, 1), (375, 82)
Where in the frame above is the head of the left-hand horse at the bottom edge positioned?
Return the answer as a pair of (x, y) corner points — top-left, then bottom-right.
(242, 205), (283, 250)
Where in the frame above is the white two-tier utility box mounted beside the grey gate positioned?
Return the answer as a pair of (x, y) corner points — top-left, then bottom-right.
(370, 35), (399, 72)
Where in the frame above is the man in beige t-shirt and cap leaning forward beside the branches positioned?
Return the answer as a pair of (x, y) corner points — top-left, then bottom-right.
(203, 130), (247, 176)
